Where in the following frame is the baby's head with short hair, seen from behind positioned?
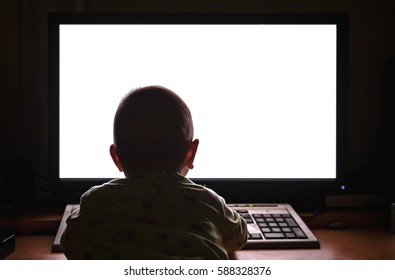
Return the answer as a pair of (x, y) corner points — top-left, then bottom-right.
(110, 86), (199, 177)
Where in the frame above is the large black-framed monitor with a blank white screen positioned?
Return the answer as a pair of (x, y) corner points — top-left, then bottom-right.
(48, 13), (348, 209)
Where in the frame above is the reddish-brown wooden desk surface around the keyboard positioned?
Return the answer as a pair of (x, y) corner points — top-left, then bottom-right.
(6, 227), (395, 260)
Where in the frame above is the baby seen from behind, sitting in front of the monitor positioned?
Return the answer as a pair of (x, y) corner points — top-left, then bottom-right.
(61, 86), (247, 259)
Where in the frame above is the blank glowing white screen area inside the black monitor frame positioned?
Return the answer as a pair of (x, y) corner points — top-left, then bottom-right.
(59, 24), (336, 178)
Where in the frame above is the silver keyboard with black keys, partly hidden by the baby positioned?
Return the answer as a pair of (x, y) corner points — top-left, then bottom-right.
(52, 204), (320, 252)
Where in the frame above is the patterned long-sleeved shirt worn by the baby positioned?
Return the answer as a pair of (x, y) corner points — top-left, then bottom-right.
(61, 172), (247, 259)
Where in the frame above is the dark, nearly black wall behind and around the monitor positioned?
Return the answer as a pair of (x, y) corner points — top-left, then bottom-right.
(0, 0), (395, 188)
